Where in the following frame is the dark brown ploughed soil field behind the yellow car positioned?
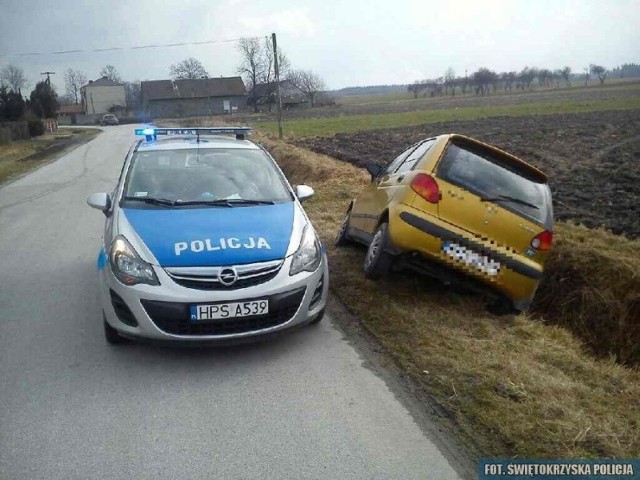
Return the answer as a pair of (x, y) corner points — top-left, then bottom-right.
(296, 110), (640, 238)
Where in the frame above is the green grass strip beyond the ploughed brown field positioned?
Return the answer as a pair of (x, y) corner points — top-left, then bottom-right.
(256, 97), (640, 137)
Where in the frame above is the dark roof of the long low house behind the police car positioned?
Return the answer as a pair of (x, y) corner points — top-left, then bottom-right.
(140, 77), (247, 100)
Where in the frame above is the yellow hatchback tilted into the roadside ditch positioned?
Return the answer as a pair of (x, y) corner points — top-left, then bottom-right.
(336, 134), (553, 313)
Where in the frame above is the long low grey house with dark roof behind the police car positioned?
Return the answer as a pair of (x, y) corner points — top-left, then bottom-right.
(141, 77), (247, 118)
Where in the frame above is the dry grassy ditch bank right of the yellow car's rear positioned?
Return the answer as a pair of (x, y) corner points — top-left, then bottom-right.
(533, 224), (640, 365)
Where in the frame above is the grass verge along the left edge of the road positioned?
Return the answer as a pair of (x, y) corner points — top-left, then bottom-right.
(0, 128), (101, 185)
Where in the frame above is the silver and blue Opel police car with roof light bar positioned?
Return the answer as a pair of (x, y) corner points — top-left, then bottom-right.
(87, 127), (329, 343)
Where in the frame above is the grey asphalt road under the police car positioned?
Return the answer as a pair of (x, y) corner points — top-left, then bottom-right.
(0, 125), (457, 480)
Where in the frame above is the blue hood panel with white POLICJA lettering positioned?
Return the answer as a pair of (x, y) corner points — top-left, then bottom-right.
(123, 202), (295, 267)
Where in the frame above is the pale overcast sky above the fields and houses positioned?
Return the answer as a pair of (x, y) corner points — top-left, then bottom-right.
(0, 0), (640, 93)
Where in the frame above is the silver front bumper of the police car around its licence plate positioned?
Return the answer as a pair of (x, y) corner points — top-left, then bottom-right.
(99, 251), (329, 343)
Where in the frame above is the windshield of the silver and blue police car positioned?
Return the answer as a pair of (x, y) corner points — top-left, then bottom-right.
(124, 148), (292, 208)
